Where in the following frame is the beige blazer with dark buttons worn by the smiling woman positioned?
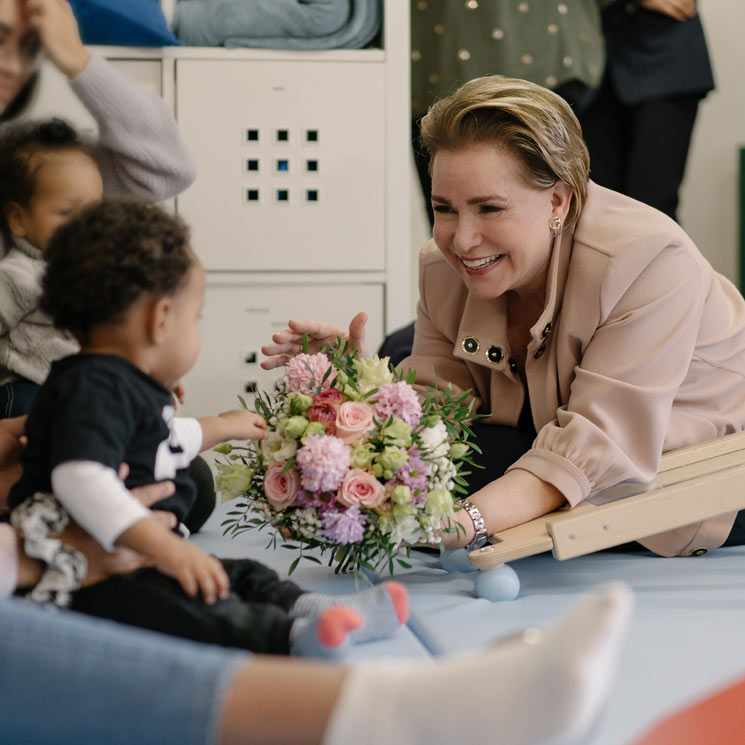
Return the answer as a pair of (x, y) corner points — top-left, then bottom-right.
(400, 182), (745, 556)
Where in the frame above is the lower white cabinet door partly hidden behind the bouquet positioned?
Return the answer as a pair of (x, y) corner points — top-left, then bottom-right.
(182, 275), (383, 416)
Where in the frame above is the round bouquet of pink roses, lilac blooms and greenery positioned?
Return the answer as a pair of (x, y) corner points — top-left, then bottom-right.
(216, 340), (477, 574)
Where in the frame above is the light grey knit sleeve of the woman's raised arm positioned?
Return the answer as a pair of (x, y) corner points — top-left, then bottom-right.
(70, 55), (195, 200)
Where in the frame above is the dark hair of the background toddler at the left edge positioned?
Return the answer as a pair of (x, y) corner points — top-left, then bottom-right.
(0, 119), (93, 233)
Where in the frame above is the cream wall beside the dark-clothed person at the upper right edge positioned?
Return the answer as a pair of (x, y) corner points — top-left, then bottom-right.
(679, 0), (745, 282)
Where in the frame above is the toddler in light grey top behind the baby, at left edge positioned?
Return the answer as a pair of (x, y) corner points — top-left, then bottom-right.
(0, 119), (103, 418)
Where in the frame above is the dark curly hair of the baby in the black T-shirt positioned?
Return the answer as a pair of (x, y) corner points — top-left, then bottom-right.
(41, 199), (196, 340)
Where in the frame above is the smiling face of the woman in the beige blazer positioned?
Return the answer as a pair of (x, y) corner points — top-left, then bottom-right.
(432, 145), (571, 298)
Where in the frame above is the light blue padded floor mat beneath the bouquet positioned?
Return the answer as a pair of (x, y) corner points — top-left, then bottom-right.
(193, 500), (745, 745)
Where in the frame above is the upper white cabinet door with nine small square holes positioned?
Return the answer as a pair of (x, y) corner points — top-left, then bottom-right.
(176, 59), (385, 271)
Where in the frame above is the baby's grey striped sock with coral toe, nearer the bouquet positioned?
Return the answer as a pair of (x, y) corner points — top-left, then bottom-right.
(290, 582), (409, 644)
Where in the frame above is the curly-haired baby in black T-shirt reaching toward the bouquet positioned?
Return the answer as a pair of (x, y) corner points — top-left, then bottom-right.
(9, 200), (408, 656)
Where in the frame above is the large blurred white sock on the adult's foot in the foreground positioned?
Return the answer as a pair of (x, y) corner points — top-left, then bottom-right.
(323, 584), (632, 745)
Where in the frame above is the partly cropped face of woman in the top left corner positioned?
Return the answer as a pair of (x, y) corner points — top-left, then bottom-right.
(0, 0), (41, 114)
